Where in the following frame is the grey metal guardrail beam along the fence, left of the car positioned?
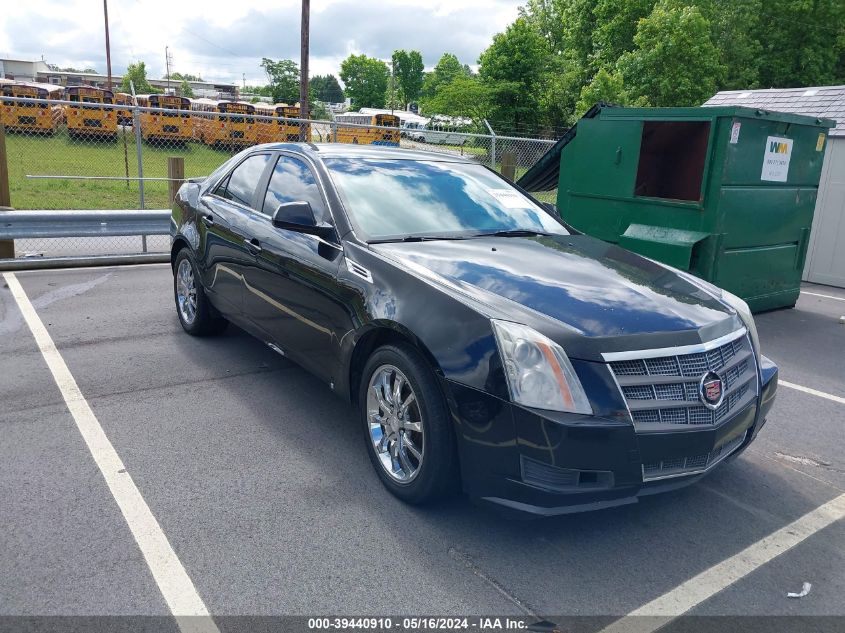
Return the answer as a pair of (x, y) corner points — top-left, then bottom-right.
(0, 209), (170, 240)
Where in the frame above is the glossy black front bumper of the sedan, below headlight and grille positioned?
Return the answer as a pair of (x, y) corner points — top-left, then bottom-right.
(445, 357), (778, 516)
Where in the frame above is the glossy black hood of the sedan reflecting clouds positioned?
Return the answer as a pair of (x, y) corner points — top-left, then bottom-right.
(372, 235), (734, 337)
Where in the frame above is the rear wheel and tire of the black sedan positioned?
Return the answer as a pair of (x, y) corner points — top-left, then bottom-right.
(173, 248), (229, 336)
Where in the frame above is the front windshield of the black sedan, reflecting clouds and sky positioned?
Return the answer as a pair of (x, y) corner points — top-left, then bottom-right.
(325, 158), (567, 241)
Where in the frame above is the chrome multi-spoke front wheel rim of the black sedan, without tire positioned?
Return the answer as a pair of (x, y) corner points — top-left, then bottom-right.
(367, 365), (425, 484)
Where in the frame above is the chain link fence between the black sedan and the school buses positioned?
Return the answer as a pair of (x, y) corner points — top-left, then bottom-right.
(0, 97), (555, 257)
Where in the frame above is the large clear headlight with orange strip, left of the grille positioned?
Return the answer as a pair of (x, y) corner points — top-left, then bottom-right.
(491, 319), (593, 415)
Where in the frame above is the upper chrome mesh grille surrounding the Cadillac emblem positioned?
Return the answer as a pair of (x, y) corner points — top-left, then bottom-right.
(605, 329), (757, 430)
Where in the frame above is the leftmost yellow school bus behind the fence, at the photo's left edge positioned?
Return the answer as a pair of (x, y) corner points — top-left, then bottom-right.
(0, 82), (63, 135)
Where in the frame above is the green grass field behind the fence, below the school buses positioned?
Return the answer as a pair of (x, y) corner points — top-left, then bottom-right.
(6, 128), (230, 209)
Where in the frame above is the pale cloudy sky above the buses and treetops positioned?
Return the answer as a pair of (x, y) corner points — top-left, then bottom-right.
(0, 0), (524, 85)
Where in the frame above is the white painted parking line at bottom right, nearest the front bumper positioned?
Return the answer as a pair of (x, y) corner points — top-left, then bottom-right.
(600, 494), (845, 633)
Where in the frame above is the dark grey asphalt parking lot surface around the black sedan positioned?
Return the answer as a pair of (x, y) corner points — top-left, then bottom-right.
(0, 265), (845, 630)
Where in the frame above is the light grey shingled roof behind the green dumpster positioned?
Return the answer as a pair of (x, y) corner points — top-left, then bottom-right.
(704, 86), (845, 136)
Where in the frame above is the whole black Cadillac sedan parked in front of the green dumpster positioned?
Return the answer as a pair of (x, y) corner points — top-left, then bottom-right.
(171, 144), (778, 515)
